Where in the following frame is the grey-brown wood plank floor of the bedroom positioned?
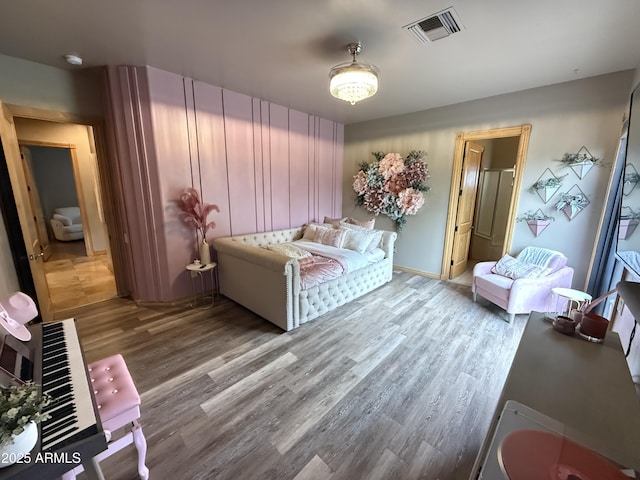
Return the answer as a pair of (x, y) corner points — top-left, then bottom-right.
(60, 272), (526, 480)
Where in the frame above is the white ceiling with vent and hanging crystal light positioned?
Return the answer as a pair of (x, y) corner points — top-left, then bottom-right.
(0, 0), (640, 124)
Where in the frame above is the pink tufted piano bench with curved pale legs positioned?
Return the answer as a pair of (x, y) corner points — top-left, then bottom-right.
(62, 354), (149, 480)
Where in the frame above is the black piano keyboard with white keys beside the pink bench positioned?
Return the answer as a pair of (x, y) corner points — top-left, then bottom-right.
(0, 319), (107, 480)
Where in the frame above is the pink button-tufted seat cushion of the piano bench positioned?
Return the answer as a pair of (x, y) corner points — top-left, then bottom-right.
(89, 354), (140, 423)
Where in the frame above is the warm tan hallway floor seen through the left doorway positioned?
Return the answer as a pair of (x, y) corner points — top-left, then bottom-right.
(44, 240), (117, 313)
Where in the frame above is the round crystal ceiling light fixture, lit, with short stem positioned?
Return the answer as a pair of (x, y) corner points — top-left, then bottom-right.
(329, 42), (380, 105)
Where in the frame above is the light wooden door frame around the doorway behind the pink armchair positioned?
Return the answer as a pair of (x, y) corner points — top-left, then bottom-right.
(440, 124), (531, 280)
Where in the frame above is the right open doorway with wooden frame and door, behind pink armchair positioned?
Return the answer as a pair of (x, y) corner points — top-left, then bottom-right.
(441, 125), (531, 285)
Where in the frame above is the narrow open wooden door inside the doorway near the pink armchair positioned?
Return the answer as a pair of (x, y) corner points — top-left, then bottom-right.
(449, 142), (484, 278)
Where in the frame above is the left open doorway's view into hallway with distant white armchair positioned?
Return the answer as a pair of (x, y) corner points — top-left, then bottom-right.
(16, 139), (117, 313)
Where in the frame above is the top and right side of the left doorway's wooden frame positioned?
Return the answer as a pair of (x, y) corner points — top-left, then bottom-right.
(3, 103), (130, 310)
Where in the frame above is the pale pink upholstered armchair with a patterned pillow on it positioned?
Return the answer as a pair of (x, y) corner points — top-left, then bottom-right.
(471, 247), (573, 322)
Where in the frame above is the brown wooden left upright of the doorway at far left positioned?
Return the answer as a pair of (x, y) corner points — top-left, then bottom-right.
(0, 101), (53, 320)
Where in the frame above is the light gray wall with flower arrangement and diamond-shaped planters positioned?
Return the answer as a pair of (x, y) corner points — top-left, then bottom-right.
(343, 71), (634, 288)
